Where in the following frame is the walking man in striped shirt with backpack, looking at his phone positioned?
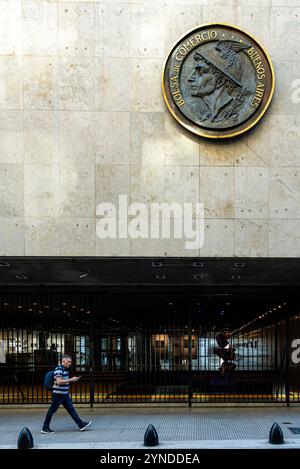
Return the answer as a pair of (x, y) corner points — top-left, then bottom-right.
(41, 355), (92, 433)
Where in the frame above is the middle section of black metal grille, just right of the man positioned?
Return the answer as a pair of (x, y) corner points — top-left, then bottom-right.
(95, 294), (192, 402)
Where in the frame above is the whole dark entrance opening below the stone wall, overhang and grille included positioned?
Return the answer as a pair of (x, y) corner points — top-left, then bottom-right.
(0, 258), (300, 405)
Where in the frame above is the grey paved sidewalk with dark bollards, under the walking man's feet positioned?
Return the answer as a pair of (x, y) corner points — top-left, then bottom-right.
(0, 406), (300, 449)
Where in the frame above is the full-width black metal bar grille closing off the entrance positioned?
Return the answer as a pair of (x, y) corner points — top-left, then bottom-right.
(0, 290), (300, 405)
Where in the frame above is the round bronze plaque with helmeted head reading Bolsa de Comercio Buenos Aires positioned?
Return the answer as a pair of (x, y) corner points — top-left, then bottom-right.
(162, 23), (275, 138)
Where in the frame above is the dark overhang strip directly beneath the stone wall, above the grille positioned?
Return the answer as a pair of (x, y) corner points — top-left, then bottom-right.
(0, 257), (300, 287)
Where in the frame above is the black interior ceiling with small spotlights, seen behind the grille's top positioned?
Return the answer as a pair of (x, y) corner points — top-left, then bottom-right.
(0, 287), (291, 330)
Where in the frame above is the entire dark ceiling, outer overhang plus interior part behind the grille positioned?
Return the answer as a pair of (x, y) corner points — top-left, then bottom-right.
(0, 257), (294, 328)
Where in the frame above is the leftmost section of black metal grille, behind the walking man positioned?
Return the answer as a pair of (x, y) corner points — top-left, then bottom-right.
(0, 294), (90, 404)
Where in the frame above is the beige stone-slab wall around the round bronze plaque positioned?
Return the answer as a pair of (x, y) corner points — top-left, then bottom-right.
(0, 0), (300, 257)
